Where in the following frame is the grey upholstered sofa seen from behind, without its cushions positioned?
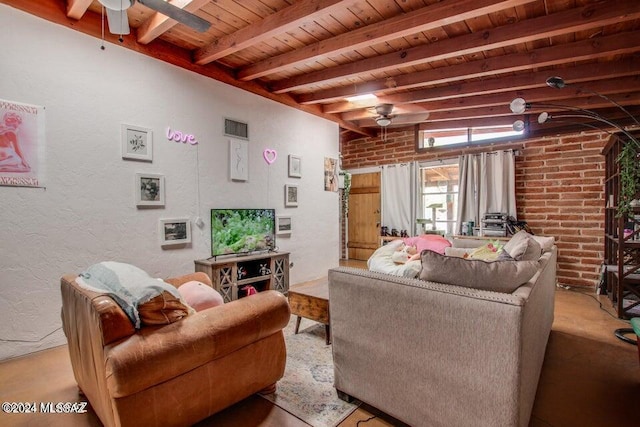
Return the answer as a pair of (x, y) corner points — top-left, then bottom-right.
(329, 237), (557, 427)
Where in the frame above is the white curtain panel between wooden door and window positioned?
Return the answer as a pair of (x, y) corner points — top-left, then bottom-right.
(381, 163), (418, 235)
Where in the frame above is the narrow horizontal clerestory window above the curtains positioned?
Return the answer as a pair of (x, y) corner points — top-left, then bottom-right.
(418, 125), (524, 149)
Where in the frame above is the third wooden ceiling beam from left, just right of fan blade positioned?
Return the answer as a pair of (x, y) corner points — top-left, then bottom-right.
(194, 0), (358, 65)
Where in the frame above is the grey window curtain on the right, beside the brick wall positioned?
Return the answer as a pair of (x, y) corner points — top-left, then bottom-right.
(456, 150), (516, 233)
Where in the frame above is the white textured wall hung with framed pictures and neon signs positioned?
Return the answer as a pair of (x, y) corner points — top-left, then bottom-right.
(0, 5), (339, 360)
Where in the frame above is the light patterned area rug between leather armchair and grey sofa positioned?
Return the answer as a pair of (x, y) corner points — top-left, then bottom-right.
(262, 316), (358, 427)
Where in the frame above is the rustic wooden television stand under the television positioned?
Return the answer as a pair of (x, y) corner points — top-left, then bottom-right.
(194, 252), (289, 302)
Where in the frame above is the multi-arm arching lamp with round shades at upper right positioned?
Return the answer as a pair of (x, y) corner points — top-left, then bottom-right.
(509, 76), (640, 148)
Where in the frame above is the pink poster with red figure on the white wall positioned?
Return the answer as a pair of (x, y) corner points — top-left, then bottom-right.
(0, 99), (45, 187)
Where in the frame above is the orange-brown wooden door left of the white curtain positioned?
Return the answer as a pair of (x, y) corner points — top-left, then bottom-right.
(347, 172), (380, 260)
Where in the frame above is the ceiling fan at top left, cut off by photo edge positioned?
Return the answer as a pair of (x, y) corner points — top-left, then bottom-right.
(98, 0), (211, 34)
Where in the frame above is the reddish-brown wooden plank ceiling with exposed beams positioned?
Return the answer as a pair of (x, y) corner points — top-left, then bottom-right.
(5, 0), (640, 144)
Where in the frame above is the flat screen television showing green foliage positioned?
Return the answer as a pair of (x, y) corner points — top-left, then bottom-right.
(211, 209), (276, 257)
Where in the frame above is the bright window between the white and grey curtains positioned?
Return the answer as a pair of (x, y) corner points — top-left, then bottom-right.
(418, 159), (460, 235)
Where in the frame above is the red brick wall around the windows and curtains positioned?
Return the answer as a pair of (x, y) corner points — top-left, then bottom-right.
(341, 131), (608, 288)
